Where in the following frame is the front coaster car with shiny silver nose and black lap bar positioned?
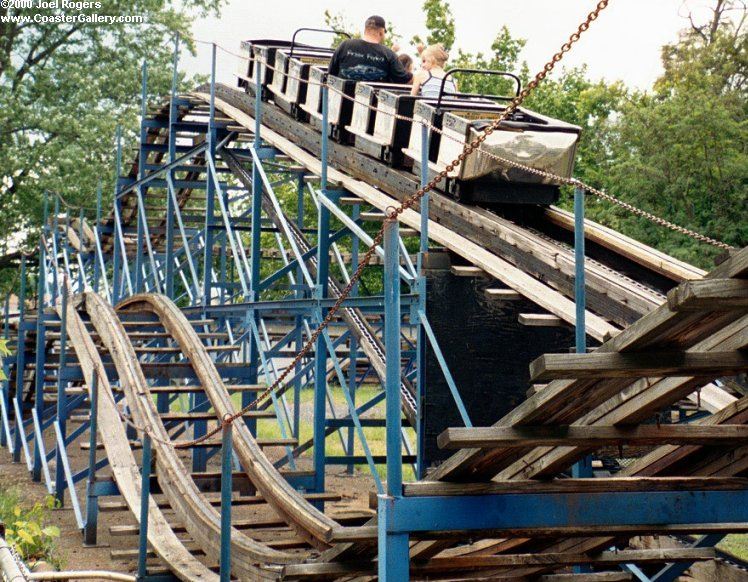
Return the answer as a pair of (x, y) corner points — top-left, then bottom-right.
(403, 69), (581, 205)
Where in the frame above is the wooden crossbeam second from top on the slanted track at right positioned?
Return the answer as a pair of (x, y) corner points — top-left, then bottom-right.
(530, 351), (748, 382)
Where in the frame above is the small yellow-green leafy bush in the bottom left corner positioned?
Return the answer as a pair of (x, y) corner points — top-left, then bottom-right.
(0, 489), (61, 568)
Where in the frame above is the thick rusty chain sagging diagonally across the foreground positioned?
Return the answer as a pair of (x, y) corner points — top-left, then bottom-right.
(174, 0), (610, 448)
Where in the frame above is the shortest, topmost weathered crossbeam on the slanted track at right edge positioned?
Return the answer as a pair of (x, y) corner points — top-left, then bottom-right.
(667, 279), (748, 311)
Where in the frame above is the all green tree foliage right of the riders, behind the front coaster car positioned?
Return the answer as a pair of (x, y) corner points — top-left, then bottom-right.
(410, 0), (748, 268)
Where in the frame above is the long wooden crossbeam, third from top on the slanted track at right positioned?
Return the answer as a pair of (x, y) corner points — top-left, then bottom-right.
(437, 424), (748, 449)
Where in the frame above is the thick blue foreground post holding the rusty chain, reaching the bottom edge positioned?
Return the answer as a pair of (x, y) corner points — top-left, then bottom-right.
(378, 218), (409, 582)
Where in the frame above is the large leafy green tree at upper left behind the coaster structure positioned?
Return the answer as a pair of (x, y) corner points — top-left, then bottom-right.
(0, 0), (224, 262)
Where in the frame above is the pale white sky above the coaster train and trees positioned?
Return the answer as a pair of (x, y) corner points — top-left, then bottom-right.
(181, 0), (708, 89)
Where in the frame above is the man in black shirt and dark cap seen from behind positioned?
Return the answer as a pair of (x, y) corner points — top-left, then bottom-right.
(328, 16), (413, 84)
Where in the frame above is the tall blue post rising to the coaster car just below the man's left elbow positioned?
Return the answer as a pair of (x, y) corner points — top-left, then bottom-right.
(314, 82), (330, 502)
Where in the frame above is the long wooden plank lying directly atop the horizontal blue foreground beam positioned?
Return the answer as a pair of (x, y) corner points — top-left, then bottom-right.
(403, 477), (748, 497)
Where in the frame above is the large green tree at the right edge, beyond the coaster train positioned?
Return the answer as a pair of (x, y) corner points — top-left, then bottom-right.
(603, 5), (748, 268)
